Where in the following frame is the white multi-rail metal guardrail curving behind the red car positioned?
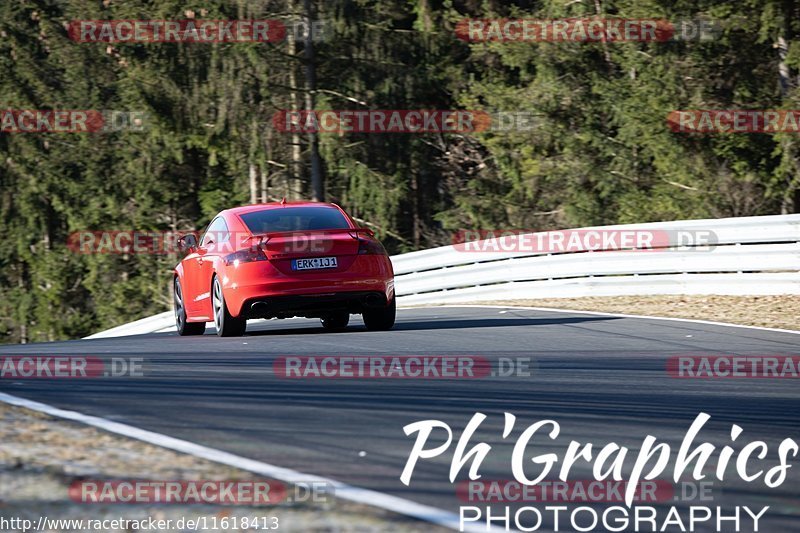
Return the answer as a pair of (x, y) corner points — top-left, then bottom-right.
(87, 214), (800, 338)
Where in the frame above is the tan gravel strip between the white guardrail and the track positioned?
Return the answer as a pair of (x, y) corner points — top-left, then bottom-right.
(476, 295), (800, 330)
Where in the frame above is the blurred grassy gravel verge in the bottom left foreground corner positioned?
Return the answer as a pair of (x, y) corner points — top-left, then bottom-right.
(0, 403), (449, 533)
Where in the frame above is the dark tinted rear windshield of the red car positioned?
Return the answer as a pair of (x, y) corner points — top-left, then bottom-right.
(241, 207), (350, 234)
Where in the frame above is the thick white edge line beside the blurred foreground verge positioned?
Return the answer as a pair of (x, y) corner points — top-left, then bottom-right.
(0, 392), (515, 533)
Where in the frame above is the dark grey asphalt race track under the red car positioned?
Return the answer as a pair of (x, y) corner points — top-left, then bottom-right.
(0, 307), (800, 532)
